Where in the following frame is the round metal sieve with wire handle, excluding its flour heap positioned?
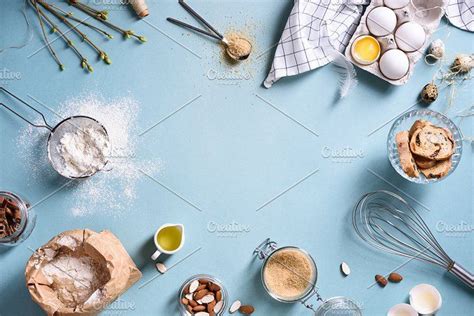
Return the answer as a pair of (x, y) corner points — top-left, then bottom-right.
(0, 87), (110, 179)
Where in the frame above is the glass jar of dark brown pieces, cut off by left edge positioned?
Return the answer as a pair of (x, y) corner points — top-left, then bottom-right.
(0, 191), (36, 247)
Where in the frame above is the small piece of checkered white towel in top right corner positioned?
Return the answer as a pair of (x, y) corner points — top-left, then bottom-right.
(446, 0), (474, 32)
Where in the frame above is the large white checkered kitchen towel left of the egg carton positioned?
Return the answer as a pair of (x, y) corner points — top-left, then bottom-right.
(263, 0), (369, 88)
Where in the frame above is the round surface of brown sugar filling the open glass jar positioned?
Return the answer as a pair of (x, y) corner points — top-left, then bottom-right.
(263, 248), (316, 300)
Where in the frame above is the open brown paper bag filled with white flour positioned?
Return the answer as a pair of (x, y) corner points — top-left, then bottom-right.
(25, 229), (141, 316)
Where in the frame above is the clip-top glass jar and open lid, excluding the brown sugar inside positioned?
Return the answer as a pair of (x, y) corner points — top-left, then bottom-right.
(253, 238), (362, 316)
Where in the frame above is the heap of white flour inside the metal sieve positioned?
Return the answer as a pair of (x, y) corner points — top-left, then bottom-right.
(56, 127), (110, 178)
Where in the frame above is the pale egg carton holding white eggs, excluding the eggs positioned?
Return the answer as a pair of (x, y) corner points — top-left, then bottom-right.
(345, 0), (447, 85)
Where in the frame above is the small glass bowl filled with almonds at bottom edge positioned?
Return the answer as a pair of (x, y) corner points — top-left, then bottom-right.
(179, 274), (227, 316)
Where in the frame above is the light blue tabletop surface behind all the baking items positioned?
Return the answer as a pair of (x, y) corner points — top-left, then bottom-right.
(0, 0), (474, 316)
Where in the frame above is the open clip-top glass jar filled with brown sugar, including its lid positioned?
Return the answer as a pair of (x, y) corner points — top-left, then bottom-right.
(254, 238), (362, 316)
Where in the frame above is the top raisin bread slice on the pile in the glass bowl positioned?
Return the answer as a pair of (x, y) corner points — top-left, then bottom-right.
(410, 125), (454, 160)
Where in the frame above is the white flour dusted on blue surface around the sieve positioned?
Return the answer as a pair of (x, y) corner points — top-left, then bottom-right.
(17, 94), (161, 217)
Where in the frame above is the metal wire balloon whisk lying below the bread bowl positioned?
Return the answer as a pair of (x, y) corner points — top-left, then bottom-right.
(352, 191), (474, 288)
